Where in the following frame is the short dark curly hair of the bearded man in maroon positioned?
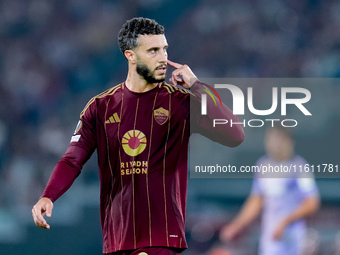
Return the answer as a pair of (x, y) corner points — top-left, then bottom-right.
(118, 17), (164, 54)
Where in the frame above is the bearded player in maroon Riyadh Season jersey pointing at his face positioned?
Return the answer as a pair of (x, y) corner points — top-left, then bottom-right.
(32, 18), (244, 255)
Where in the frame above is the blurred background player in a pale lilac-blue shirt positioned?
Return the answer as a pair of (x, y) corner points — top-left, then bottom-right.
(220, 127), (319, 255)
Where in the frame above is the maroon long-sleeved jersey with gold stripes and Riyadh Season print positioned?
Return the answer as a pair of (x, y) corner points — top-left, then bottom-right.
(42, 82), (244, 253)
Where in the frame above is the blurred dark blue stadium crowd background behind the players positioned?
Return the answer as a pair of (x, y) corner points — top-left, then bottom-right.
(0, 0), (340, 255)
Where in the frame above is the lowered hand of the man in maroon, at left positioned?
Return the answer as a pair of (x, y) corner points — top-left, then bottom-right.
(32, 197), (53, 229)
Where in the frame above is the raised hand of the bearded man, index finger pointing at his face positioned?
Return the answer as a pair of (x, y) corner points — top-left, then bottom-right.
(168, 60), (198, 89)
